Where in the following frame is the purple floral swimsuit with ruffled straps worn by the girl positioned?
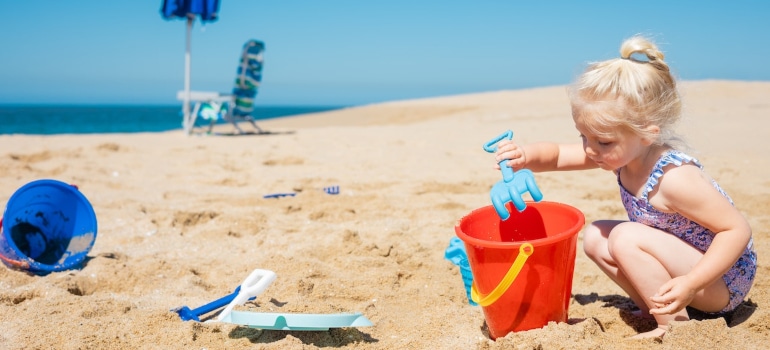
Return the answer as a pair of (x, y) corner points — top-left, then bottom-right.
(617, 150), (757, 312)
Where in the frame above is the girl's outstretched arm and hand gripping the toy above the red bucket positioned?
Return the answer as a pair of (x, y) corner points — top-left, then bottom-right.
(495, 140), (597, 172)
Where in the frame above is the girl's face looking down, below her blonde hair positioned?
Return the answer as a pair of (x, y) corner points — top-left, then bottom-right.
(574, 116), (649, 170)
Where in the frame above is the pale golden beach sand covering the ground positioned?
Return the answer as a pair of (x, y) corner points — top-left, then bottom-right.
(0, 81), (770, 349)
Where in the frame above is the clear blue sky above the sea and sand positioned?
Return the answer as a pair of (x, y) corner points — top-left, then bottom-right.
(0, 0), (770, 106)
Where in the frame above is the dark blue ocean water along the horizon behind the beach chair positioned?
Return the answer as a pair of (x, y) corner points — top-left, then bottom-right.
(0, 105), (343, 135)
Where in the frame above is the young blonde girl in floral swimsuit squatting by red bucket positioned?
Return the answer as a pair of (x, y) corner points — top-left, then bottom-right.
(495, 36), (756, 337)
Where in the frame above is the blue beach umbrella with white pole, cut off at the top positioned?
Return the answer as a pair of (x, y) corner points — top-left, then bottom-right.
(160, 0), (219, 134)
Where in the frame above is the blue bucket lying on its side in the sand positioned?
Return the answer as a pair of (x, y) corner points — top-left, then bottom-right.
(0, 180), (96, 275)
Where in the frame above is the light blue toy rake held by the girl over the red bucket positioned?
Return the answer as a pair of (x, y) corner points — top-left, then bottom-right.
(484, 130), (543, 221)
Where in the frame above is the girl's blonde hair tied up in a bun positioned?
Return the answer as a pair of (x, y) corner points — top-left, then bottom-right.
(569, 36), (685, 147)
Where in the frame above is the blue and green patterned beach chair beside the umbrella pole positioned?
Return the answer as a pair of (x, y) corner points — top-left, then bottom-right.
(177, 39), (265, 134)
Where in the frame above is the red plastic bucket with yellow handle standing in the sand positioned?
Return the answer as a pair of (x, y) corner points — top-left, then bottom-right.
(455, 202), (585, 339)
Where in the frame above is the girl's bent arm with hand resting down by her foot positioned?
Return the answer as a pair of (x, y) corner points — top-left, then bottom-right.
(651, 166), (751, 313)
